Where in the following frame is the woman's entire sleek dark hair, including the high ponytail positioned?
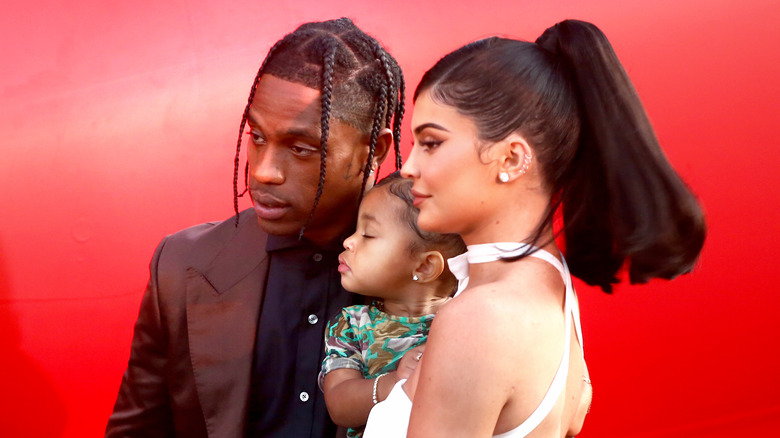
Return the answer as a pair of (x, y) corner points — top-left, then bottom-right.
(414, 20), (706, 292)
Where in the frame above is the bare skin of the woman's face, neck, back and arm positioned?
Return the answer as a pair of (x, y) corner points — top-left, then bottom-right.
(402, 92), (590, 438)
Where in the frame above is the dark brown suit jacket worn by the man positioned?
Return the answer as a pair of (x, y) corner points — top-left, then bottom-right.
(106, 210), (268, 438)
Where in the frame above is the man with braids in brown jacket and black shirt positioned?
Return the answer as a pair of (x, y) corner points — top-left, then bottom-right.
(106, 18), (404, 437)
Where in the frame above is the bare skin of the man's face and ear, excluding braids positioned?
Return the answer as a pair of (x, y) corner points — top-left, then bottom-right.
(247, 75), (392, 245)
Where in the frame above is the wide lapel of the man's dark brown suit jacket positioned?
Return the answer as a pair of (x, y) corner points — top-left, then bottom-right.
(187, 212), (268, 437)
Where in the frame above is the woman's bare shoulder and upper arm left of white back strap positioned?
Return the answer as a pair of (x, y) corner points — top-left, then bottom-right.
(408, 278), (564, 438)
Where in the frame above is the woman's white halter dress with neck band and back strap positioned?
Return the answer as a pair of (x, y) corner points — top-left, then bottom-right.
(363, 242), (582, 438)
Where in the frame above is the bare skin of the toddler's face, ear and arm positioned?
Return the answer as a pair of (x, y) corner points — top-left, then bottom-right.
(323, 186), (450, 427)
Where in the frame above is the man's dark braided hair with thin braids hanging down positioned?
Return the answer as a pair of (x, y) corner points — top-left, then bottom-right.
(233, 18), (405, 236)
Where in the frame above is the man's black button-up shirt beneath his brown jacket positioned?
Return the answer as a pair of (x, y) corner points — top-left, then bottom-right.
(246, 236), (354, 438)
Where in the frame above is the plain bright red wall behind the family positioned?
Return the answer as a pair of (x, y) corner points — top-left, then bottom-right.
(0, 0), (780, 438)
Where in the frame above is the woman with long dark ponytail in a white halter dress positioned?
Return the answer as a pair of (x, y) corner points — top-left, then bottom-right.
(365, 20), (705, 438)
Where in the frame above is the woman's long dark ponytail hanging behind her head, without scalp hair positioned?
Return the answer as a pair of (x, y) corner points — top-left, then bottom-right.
(536, 20), (706, 292)
